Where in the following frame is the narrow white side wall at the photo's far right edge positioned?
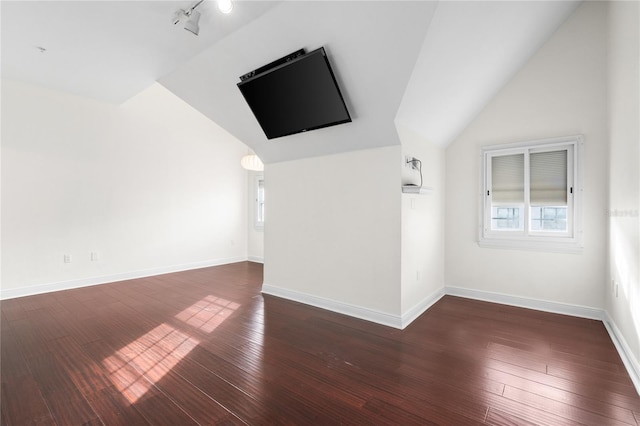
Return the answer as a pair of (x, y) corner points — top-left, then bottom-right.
(606, 1), (640, 382)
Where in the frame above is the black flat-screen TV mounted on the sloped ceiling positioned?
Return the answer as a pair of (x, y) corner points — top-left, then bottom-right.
(238, 47), (351, 139)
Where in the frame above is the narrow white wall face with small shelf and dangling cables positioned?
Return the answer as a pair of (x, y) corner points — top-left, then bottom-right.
(397, 125), (445, 315)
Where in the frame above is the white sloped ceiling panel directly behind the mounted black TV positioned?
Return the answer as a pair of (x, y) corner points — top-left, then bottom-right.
(160, 1), (437, 163)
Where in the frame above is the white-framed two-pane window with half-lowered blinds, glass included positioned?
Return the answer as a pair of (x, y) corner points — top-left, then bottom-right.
(480, 136), (582, 248)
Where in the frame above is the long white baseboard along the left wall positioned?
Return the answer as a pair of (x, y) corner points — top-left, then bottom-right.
(0, 256), (247, 300)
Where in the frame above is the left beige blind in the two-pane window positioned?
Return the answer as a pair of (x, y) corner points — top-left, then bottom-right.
(491, 154), (524, 205)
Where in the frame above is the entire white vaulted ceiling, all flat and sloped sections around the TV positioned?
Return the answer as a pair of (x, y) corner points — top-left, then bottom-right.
(0, 0), (579, 162)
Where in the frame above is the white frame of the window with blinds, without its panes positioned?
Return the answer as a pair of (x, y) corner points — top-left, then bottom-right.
(478, 135), (584, 253)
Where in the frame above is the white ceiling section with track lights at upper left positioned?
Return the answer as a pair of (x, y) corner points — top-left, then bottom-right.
(0, 0), (276, 103)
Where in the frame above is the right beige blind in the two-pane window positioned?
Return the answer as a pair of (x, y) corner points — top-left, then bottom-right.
(529, 149), (567, 206)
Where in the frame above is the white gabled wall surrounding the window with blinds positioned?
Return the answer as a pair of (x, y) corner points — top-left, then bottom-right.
(445, 2), (608, 309)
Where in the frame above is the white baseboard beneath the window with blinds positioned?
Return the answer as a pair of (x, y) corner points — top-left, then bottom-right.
(444, 287), (603, 320)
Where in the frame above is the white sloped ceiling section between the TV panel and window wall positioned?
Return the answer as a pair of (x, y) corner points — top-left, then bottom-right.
(396, 1), (580, 146)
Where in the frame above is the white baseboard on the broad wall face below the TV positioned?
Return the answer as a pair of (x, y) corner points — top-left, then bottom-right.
(262, 283), (402, 328)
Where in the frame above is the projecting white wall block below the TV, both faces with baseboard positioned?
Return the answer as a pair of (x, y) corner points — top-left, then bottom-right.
(263, 138), (444, 328)
